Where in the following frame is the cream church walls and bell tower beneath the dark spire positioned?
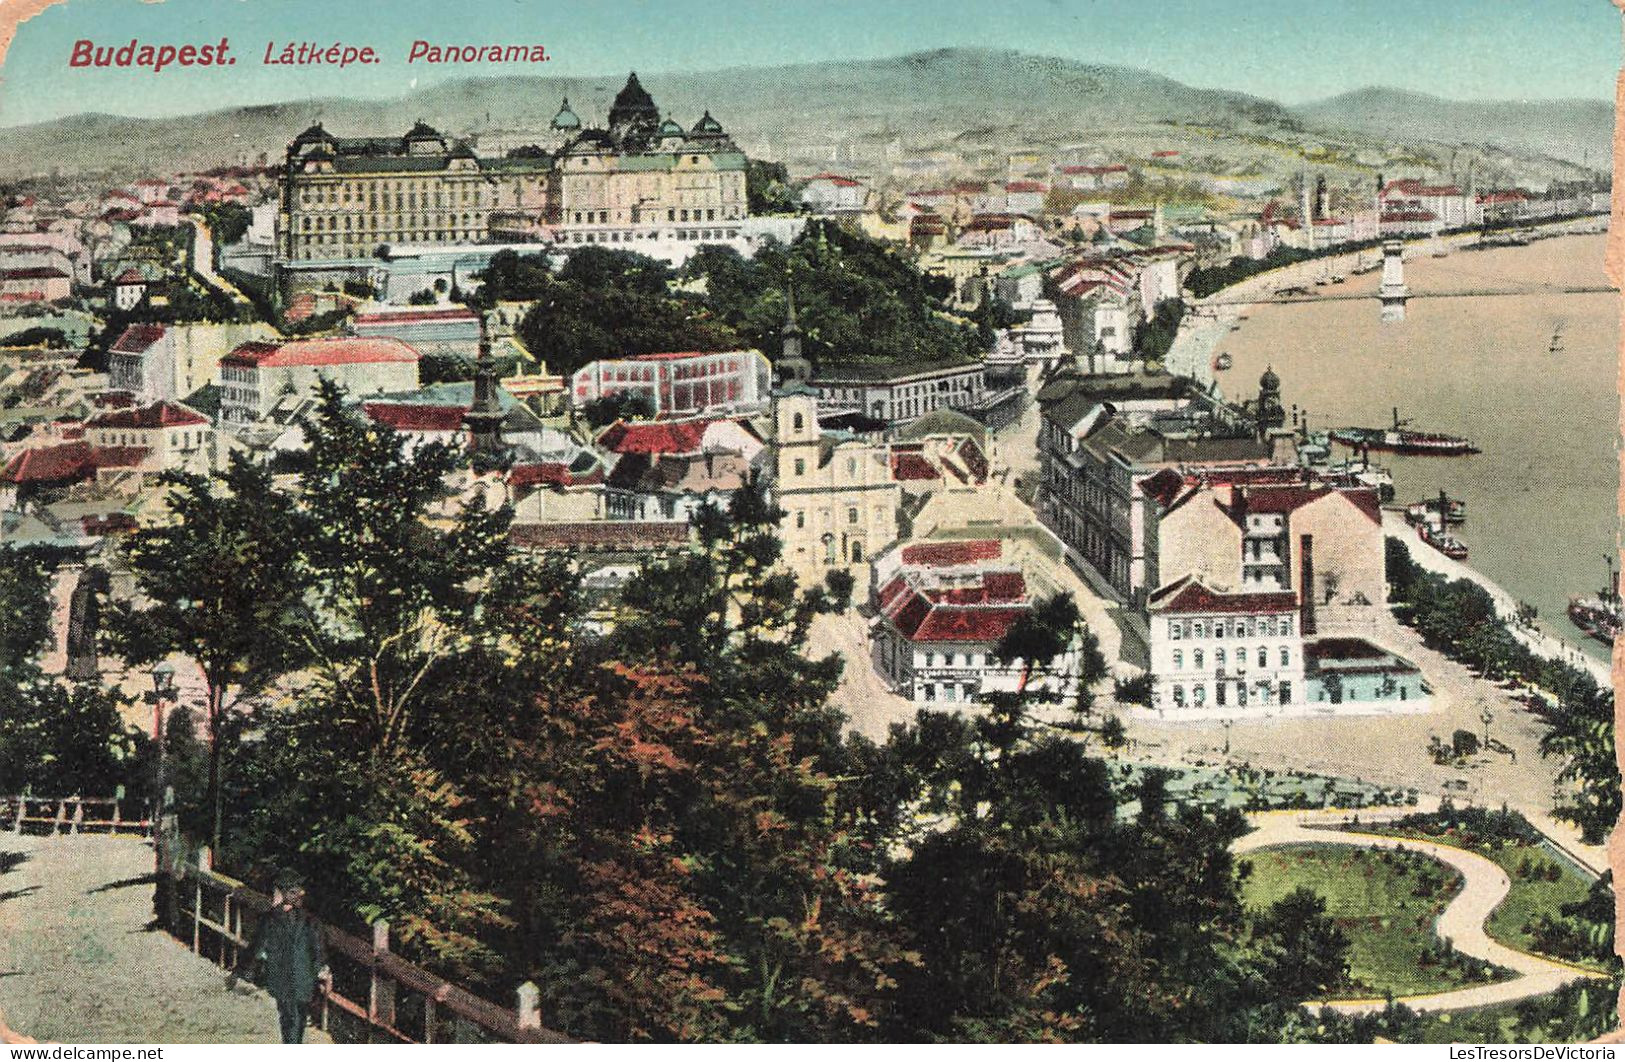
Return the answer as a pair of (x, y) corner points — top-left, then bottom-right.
(774, 386), (902, 585)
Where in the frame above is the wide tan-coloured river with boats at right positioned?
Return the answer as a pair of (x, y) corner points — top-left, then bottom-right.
(1217, 235), (1620, 656)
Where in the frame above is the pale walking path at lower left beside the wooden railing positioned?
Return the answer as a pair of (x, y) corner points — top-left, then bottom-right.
(0, 833), (327, 1044)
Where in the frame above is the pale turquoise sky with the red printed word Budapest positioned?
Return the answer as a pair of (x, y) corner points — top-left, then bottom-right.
(0, 0), (1622, 127)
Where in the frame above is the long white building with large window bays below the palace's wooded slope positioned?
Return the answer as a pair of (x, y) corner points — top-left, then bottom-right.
(570, 351), (774, 416)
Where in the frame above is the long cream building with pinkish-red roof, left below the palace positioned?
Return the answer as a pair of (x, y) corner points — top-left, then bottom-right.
(219, 338), (418, 425)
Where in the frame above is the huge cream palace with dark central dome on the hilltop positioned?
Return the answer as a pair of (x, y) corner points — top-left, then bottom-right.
(276, 73), (749, 263)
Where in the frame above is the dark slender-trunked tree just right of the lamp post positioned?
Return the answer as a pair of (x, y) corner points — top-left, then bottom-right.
(106, 458), (301, 851)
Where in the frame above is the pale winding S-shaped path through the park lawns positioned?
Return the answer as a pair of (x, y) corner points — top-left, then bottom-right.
(1233, 809), (1601, 1013)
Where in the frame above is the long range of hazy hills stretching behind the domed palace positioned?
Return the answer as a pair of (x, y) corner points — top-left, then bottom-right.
(0, 49), (1612, 184)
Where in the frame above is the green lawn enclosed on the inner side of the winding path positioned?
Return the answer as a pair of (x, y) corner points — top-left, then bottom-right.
(1242, 844), (1502, 999)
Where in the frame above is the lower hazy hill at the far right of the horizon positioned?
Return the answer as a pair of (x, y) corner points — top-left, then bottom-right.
(1292, 88), (1614, 169)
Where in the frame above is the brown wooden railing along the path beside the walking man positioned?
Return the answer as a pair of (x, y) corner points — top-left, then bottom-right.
(159, 848), (572, 1044)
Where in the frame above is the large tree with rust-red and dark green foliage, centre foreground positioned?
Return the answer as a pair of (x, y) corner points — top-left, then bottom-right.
(507, 486), (910, 1041)
